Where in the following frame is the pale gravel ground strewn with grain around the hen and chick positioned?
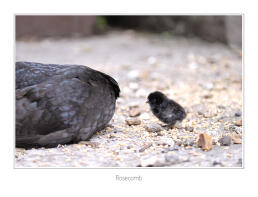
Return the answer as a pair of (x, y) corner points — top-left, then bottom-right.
(15, 31), (242, 168)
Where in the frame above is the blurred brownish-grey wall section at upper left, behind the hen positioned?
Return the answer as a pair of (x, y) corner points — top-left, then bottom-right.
(15, 15), (96, 38)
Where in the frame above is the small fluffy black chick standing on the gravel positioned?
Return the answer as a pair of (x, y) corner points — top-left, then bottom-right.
(147, 91), (186, 126)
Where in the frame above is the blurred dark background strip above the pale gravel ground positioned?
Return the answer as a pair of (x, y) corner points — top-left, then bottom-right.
(16, 15), (242, 48)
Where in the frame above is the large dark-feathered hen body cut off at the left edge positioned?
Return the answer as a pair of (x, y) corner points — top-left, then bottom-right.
(16, 62), (120, 148)
